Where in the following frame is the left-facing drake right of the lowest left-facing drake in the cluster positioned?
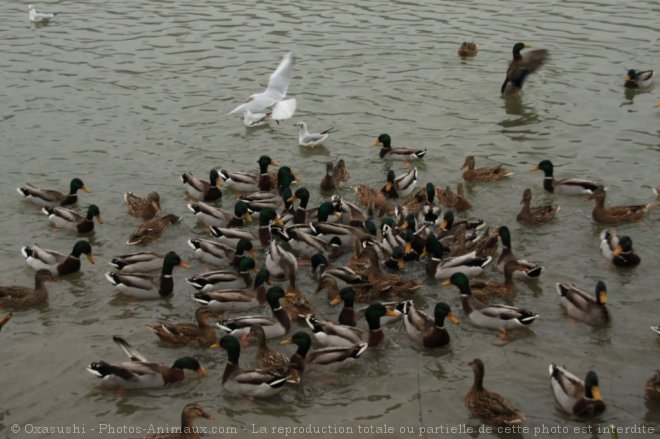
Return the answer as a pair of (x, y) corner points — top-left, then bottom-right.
(280, 331), (369, 374)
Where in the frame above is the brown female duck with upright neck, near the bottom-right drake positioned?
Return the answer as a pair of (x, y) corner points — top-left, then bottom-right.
(465, 358), (525, 426)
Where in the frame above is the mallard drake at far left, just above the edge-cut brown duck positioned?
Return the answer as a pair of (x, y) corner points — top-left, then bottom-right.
(21, 241), (94, 276)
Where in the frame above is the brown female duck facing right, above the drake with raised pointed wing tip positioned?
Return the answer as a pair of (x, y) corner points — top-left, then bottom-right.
(147, 306), (220, 348)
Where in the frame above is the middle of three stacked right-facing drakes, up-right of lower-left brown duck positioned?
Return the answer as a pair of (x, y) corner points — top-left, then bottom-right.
(192, 268), (270, 312)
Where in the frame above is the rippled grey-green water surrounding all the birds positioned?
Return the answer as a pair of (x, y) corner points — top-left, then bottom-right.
(0, 0), (660, 437)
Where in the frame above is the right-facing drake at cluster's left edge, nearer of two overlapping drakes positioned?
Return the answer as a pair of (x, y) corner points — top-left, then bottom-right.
(105, 251), (188, 299)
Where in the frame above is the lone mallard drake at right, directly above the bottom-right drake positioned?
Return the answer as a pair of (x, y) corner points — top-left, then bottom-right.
(555, 280), (612, 326)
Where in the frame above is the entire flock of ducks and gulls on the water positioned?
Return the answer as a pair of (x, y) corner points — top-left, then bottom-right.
(0, 19), (660, 437)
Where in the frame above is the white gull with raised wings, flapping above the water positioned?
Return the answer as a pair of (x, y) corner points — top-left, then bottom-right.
(229, 52), (296, 121)
